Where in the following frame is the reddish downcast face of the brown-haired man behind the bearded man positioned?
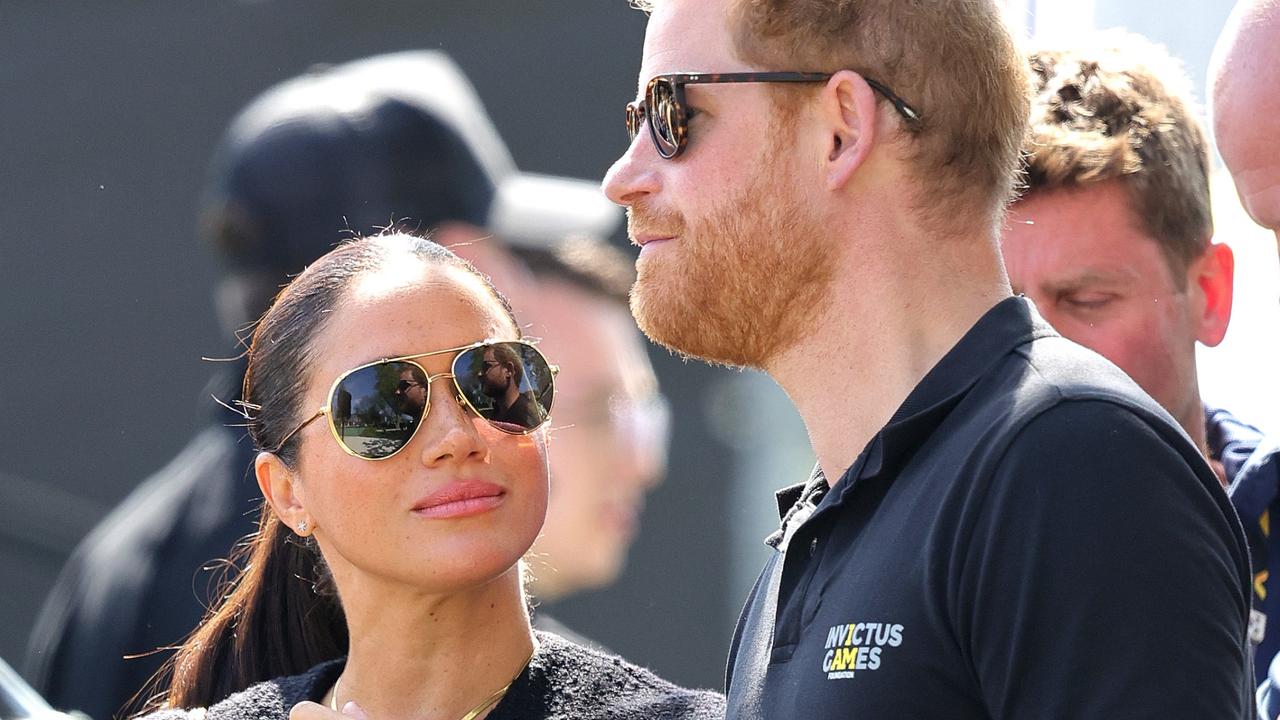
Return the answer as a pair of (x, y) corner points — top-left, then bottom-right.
(1002, 182), (1225, 427)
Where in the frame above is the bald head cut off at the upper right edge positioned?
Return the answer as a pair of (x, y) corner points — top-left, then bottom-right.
(1210, 0), (1280, 250)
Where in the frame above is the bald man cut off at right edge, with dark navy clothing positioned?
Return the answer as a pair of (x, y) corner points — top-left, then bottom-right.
(1210, 0), (1280, 717)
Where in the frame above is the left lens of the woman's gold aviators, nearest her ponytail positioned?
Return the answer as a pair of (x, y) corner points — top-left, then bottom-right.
(329, 361), (428, 459)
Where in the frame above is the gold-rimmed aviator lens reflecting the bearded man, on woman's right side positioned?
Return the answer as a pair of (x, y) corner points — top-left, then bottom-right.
(453, 342), (556, 434)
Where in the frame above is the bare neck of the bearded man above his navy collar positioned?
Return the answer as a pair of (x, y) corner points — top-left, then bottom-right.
(767, 233), (1011, 486)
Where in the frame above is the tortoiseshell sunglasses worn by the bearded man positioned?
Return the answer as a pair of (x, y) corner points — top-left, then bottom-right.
(627, 73), (920, 160)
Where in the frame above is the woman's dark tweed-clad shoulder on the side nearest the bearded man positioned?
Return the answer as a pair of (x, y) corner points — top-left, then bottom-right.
(512, 632), (724, 720)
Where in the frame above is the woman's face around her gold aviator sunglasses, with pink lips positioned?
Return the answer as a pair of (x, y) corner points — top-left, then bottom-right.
(285, 261), (548, 593)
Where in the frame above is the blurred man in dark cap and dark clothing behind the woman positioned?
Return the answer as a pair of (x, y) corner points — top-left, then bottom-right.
(20, 53), (618, 720)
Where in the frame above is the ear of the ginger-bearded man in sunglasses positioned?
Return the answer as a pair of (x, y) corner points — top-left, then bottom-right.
(819, 70), (877, 190)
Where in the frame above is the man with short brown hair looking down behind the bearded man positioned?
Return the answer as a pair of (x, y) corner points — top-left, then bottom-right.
(1002, 32), (1280, 680)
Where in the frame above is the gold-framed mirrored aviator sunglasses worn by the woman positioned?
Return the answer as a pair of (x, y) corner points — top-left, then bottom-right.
(276, 341), (559, 460)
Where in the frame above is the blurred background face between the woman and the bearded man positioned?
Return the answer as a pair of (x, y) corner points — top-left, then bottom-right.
(530, 281), (667, 600)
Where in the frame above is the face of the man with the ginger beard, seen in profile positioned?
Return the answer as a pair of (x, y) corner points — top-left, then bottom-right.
(604, 0), (833, 366)
